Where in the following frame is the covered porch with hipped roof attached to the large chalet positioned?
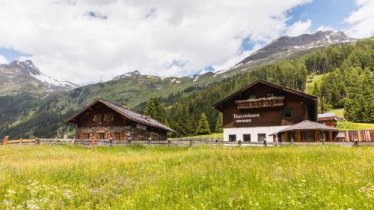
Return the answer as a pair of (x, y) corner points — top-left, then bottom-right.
(271, 120), (338, 142)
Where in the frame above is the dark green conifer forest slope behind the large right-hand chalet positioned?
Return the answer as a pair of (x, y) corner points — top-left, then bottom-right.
(141, 39), (374, 136)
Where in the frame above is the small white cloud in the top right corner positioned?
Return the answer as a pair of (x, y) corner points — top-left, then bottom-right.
(345, 0), (374, 38)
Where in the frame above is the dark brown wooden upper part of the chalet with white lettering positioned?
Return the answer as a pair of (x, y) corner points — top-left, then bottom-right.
(214, 80), (317, 128)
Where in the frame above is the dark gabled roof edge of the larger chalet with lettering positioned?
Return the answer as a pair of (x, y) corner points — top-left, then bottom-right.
(212, 79), (317, 108)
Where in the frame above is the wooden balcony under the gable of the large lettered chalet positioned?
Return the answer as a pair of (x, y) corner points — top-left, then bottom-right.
(235, 97), (284, 109)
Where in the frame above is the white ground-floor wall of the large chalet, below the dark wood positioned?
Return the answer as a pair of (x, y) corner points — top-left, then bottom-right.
(223, 126), (289, 142)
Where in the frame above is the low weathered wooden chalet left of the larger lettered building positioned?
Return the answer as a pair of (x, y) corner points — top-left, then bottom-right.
(67, 99), (175, 141)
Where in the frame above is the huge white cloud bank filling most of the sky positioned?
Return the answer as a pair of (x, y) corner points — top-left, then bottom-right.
(0, 0), (310, 83)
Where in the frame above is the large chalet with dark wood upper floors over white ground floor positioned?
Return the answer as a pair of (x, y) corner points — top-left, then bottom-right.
(213, 80), (335, 142)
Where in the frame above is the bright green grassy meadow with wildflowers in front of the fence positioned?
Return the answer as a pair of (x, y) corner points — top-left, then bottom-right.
(0, 145), (374, 209)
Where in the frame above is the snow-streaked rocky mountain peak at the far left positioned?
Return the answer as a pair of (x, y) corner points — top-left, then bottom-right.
(0, 60), (77, 95)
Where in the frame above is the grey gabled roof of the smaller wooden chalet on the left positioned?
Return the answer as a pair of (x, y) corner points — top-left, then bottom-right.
(67, 99), (175, 132)
